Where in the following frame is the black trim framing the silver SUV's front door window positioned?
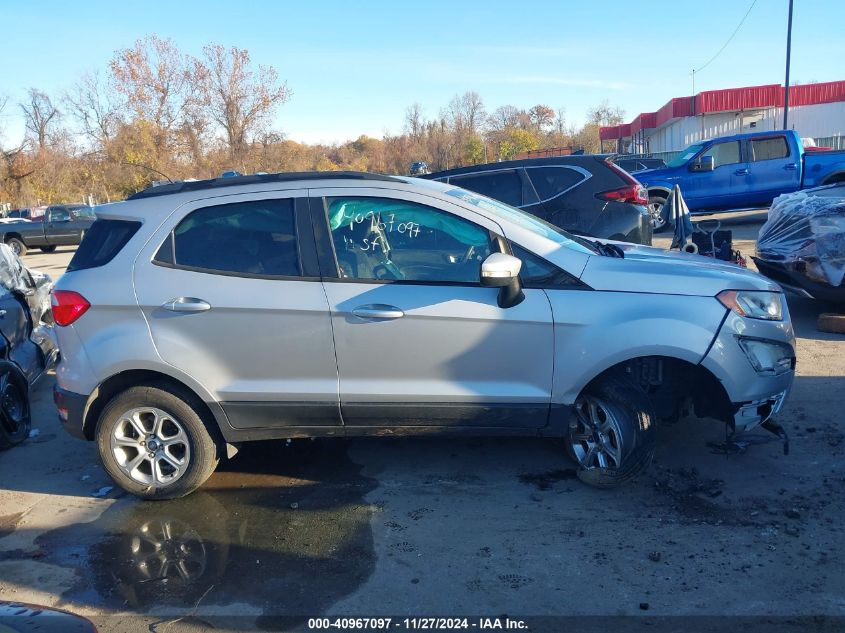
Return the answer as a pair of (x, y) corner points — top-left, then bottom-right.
(311, 191), (505, 288)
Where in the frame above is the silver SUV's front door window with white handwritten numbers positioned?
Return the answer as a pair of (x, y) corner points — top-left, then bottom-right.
(326, 197), (493, 284)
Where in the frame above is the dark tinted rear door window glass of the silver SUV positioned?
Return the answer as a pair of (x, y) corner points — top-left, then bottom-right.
(162, 199), (300, 277)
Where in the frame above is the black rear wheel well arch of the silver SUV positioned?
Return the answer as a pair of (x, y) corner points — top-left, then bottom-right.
(82, 369), (222, 445)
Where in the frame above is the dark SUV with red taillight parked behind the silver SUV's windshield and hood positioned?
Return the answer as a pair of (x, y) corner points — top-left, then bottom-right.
(422, 154), (652, 244)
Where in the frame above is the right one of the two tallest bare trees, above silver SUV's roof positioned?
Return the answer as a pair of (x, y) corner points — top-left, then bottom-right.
(194, 44), (291, 165)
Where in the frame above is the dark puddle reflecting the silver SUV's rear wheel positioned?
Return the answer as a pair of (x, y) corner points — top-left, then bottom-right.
(39, 440), (375, 616)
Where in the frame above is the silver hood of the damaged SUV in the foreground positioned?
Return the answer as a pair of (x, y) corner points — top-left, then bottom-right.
(581, 242), (780, 297)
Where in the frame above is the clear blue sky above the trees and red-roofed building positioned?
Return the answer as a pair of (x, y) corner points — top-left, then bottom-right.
(0, 0), (845, 143)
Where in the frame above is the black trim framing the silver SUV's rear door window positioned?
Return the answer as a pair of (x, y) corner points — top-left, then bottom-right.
(150, 191), (321, 282)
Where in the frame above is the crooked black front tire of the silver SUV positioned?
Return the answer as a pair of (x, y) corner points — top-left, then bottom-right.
(566, 375), (657, 488)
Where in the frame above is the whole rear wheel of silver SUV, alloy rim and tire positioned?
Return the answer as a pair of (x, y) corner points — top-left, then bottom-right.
(97, 387), (218, 499)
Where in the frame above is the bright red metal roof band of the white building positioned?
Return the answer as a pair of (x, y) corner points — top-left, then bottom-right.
(599, 81), (845, 141)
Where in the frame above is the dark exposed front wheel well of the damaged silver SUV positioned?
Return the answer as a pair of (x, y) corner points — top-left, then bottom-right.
(583, 356), (734, 423)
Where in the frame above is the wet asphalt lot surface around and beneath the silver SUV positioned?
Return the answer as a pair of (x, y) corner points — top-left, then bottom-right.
(0, 213), (845, 631)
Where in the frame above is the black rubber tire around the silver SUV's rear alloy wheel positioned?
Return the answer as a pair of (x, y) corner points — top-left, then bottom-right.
(96, 384), (220, 499)
